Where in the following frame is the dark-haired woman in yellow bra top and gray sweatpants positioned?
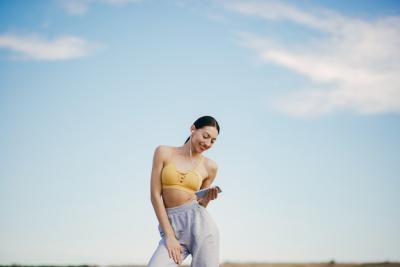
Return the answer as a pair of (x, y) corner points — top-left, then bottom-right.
(148, 116), (219, 267)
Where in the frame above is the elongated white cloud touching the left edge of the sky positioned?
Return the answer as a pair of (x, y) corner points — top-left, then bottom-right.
(0, 34), (100, 60)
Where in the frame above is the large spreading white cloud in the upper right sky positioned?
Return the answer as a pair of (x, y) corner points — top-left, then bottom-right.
(224, 1), (400, 116)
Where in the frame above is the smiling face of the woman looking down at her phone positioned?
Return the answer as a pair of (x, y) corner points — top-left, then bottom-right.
(191, 125), (218, 153)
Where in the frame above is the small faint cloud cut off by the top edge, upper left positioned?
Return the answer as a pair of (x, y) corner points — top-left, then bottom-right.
(59, 0), (142, 15)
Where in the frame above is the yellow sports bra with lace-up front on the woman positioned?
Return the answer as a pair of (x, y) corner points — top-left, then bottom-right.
(161, 156), (203, 193)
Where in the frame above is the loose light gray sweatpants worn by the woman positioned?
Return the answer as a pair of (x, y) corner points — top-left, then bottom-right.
(147, 200), (219, 267)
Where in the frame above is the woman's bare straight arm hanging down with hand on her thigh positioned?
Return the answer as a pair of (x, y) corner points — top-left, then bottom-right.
(150, 146), (182, 264)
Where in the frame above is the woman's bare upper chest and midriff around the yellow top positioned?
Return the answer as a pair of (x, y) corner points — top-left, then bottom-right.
(162, 147), (208, 208)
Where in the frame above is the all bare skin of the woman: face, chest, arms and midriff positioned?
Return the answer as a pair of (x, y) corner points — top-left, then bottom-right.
(150, 125), (218, 264)
